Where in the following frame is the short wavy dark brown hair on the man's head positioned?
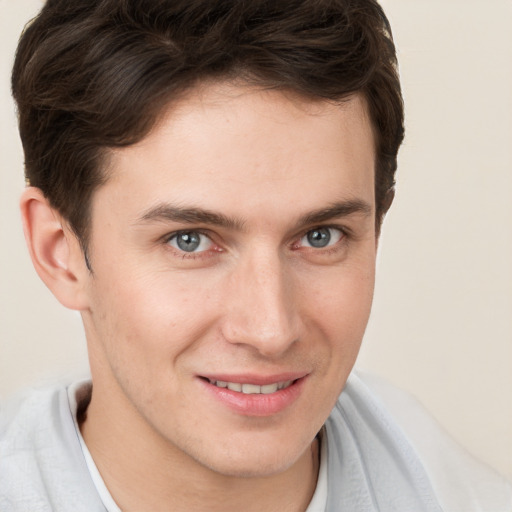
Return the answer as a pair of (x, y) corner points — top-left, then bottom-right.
(12, 0), (404, 248)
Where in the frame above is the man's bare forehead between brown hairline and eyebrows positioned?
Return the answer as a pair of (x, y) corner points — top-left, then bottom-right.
(93, 84), (375, 225)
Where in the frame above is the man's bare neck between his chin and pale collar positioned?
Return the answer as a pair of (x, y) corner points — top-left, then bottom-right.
(81, 382), (319, 512)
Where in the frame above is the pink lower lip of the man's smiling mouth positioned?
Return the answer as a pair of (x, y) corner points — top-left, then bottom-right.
(200, 377), (306, 416)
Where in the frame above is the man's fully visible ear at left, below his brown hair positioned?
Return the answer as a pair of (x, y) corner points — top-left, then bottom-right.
(20, 187), (90, 310)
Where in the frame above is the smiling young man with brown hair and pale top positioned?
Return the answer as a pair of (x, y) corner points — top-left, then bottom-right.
(0, 0), (510, 512)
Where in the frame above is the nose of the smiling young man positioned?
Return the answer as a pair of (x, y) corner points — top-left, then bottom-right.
(222, 250), (299, 357)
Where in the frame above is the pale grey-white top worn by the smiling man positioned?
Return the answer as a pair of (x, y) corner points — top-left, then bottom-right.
(0, 375), (512, 512)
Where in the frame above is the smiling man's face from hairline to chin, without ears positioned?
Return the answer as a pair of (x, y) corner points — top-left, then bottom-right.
(83, 85), (376, 476)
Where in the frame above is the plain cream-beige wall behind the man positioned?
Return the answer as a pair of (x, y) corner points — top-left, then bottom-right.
(0, 0), (512, 480)
